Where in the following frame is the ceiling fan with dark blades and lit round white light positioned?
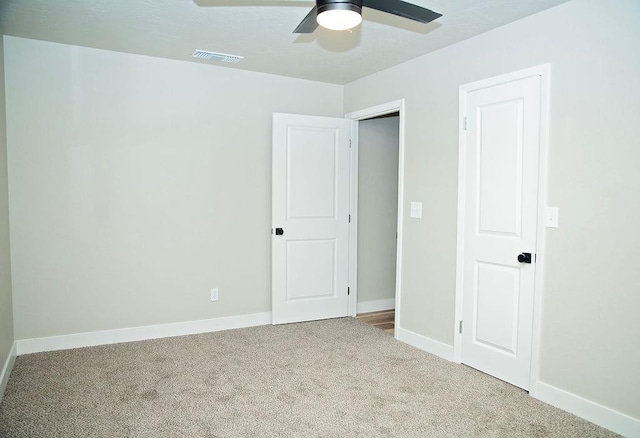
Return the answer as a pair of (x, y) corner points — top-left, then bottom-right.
(293, 0), (442, 33)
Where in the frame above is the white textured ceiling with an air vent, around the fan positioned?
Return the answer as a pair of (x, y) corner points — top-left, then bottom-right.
(0, 0), (568, 84)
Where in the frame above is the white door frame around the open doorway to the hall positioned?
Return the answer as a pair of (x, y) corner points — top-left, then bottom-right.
(345, 99), (404, 336)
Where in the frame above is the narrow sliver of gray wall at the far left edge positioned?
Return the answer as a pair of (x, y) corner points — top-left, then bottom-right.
(0, 30), (13, 376)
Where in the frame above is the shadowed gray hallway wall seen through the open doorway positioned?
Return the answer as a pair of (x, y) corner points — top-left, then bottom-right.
(358, 117), (399, 303)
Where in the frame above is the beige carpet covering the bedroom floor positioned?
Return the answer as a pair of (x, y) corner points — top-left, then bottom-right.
(0, 318), (615, 438)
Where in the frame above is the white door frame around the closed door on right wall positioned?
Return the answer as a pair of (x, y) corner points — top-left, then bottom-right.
(453, 64), (551, 397)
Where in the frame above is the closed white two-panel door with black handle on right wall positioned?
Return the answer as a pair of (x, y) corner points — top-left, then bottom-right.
(462, 76), (541, 389)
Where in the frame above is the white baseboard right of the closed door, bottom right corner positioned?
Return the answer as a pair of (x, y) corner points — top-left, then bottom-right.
(535, 382), (640, 437)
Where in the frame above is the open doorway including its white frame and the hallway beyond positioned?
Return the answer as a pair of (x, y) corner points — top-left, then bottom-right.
(346, 101), (404, 334)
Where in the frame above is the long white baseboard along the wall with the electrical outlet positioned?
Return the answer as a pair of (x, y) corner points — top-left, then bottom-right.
(16, 312), (271, 355)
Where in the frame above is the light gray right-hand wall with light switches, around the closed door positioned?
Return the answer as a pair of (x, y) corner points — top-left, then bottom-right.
(345, 0), (640, 418)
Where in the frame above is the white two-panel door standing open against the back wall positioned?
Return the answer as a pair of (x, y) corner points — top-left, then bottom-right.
(271, 114), (351, 324)
